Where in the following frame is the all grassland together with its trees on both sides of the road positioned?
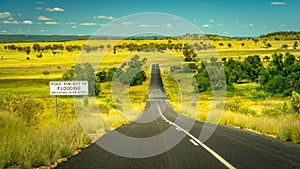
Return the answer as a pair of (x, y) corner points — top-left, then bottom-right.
(0, 34), (300, 168)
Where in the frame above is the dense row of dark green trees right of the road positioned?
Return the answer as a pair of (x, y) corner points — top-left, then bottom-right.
(195, 53), (300, 96)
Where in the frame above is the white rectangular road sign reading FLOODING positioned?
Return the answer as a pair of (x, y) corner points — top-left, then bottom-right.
(49, 81), (89, 96)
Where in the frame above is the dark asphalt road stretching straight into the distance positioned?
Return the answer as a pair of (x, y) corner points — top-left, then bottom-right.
(57, 65), (300, 169)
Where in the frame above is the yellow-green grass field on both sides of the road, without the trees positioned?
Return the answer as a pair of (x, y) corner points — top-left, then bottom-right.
(0, 40), (300, 168)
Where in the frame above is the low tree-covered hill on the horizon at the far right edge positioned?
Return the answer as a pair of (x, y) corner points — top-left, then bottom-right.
(258, 31), (300, 40)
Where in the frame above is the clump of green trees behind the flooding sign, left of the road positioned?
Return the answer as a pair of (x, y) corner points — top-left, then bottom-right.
(62, 55), (147, 96)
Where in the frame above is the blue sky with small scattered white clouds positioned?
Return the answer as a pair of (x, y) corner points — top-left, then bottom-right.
(0, 0), (300, 36)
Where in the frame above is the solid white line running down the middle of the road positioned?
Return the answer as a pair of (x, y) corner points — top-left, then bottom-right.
(157, 105), (235, 169)
